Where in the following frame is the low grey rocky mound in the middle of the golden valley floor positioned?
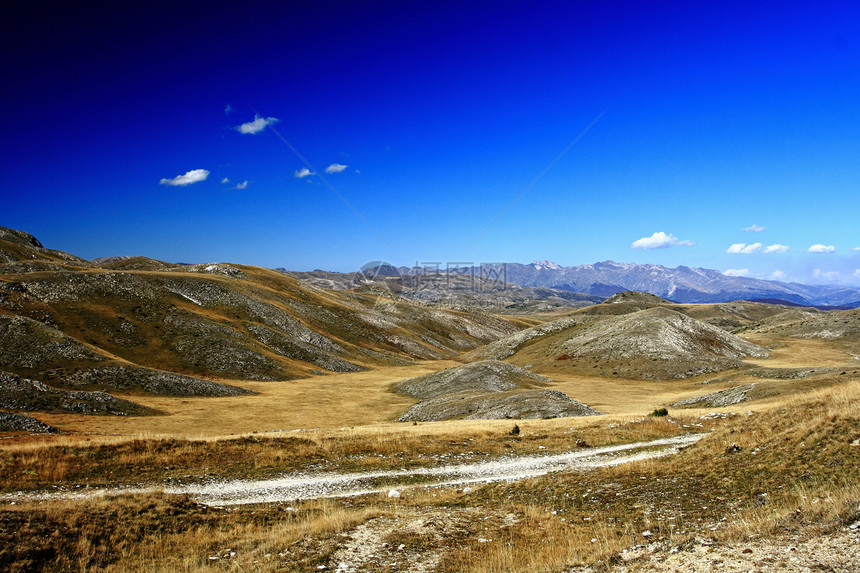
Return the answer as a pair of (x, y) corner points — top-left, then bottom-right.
(394, 360), (599, 422)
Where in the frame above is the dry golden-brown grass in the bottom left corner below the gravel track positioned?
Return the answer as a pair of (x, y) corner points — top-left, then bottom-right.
(0, 494), (381, 572)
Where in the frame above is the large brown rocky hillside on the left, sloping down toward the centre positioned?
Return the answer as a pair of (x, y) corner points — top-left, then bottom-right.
(0, 225), (518, 412)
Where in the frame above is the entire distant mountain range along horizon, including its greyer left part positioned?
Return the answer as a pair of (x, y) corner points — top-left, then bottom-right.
(284, 261), (860, 309)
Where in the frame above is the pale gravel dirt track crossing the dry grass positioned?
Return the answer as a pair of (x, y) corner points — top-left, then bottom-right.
(0, 434), (704, 506)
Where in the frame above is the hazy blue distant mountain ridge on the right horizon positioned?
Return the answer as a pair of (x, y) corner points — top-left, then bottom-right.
(473, 261), (860, 308)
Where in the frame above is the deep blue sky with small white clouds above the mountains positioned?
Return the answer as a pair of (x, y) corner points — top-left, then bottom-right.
(0, 2), (860, 285)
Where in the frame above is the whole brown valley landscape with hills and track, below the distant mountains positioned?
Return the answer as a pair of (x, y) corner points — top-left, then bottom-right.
(0, 229), (860, 571)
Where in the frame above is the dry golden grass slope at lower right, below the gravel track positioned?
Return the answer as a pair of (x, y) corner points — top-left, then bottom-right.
(434, 381), (860, 572)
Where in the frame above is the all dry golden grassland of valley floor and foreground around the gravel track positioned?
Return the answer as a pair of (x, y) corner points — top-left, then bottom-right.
(0, 332), (860, 571)
